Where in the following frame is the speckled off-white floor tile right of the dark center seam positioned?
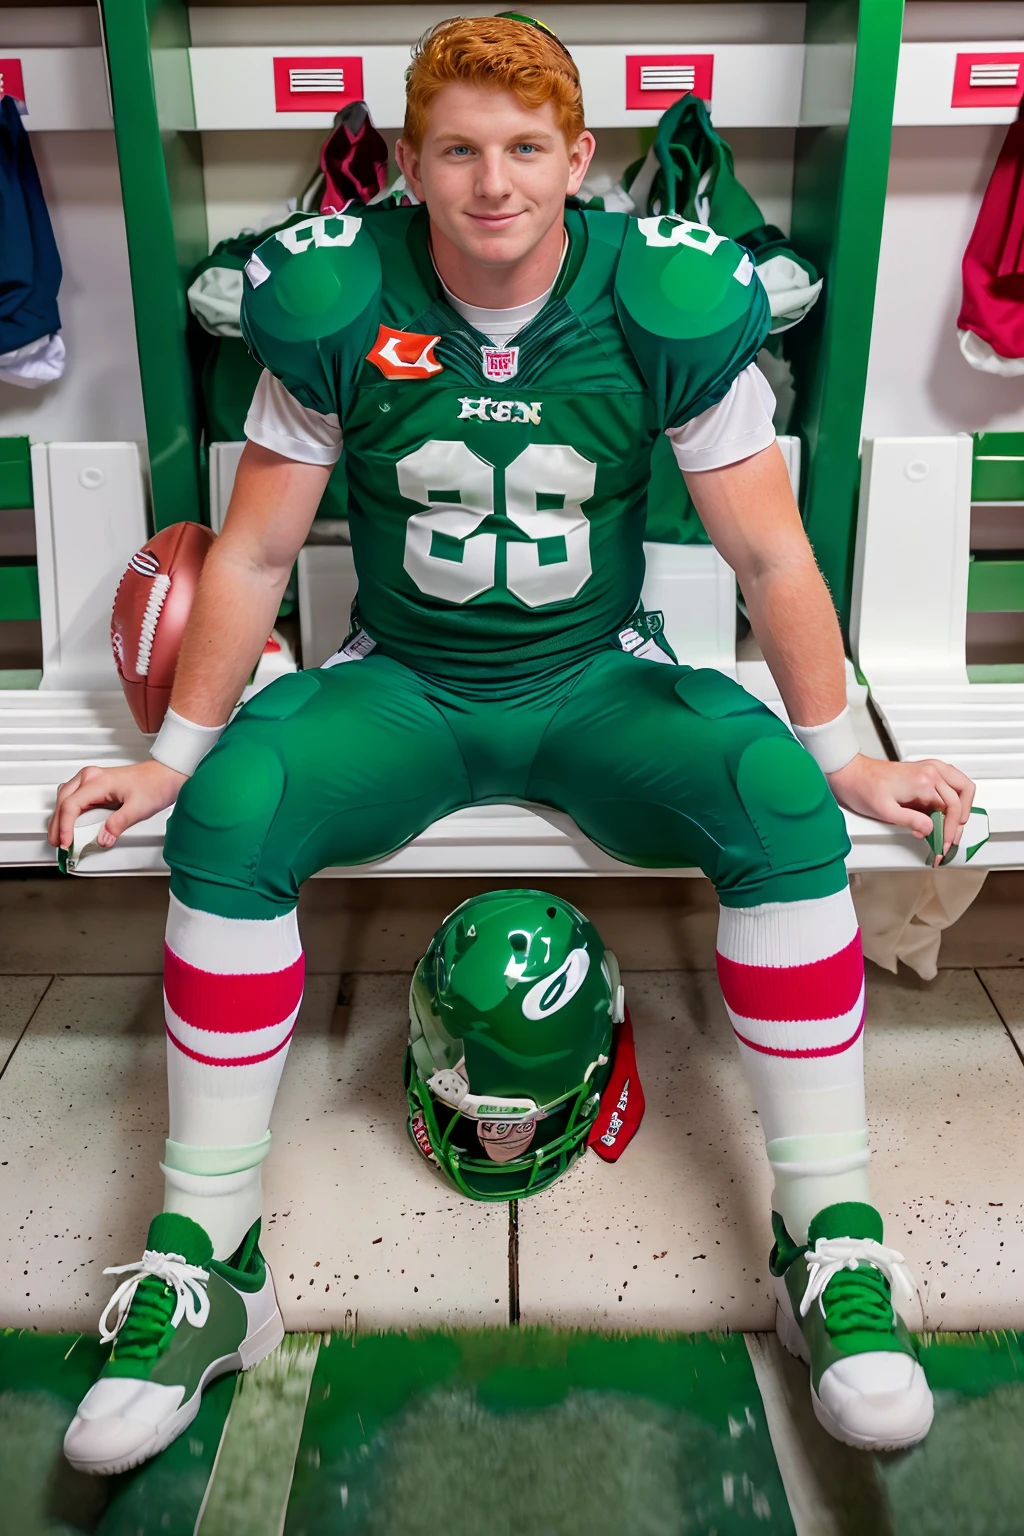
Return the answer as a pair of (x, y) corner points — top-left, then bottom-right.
(519, 966), (1024, 1329)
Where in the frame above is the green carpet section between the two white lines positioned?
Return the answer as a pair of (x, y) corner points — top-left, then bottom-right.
(286, 1329), (794, 1536)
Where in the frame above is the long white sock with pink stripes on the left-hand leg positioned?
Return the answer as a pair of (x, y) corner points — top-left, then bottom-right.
(160, 895), (304, 1260)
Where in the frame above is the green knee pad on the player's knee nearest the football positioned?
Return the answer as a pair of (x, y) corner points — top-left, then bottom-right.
(164, 740), (286, 886)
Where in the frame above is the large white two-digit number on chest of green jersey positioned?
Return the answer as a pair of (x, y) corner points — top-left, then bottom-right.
(396, 441), (597, 608)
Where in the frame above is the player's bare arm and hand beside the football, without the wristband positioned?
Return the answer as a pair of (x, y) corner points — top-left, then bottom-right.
(48, 442), (332, 848)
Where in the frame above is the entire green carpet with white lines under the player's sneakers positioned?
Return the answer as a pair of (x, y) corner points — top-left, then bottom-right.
(0, 1329), (1024, 1536)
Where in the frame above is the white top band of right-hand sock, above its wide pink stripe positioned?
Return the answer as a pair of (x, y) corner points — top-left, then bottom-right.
(717, 888), (857, 966)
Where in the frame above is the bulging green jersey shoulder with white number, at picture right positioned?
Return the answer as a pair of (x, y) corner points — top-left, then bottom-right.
(616, 215), (771, 427)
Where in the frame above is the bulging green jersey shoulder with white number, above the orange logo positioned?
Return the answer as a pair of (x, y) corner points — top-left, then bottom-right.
(241, 214), (381, 415)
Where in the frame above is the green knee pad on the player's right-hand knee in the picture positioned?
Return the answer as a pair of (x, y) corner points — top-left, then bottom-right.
(735, 733), (849, 872)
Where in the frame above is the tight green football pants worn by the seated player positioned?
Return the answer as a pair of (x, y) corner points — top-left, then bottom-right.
(166, 650), (849, 919)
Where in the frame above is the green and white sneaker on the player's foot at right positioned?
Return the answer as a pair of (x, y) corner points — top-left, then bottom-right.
(769, 1201), (933, 1450)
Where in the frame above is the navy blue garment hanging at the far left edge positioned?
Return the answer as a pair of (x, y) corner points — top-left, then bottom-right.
(0, 95), (61, 355)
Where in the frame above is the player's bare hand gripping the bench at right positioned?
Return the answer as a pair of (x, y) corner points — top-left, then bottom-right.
(827, 753), (975, 865)
